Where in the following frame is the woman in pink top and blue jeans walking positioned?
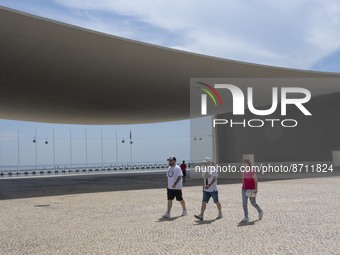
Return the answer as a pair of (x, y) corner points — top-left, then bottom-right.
(241, 159), (263, 223)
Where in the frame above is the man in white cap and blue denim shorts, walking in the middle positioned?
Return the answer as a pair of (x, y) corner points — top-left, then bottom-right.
(194, 157), (223, 220)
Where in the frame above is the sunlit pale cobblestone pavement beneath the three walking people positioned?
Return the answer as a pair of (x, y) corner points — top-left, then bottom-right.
(0, 177), (340, 255)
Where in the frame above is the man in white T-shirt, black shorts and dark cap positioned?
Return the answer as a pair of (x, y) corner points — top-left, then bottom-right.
(162, 156), (188, 218)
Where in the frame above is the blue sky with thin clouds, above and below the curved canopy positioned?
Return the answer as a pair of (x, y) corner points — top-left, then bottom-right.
(0, 0), (340, 165)
